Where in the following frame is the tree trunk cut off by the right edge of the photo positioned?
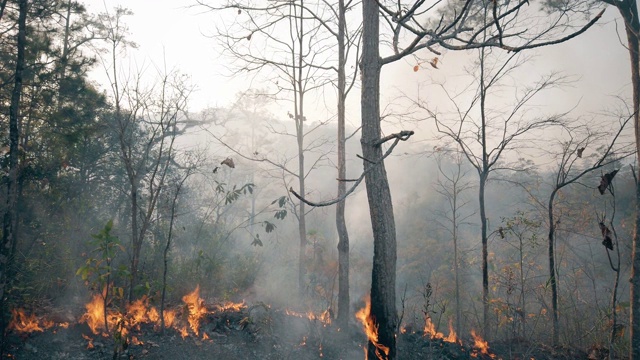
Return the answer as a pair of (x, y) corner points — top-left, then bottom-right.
(624, 0), (640, 360)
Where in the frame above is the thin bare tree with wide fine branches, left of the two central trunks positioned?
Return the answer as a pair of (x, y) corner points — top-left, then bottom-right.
(198, 0), (338, 298)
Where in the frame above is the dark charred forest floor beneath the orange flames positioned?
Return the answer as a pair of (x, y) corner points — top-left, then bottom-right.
(4, 305), (606, 360)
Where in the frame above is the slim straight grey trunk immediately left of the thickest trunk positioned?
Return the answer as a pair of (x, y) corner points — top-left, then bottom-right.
(336, 0), (350, 329)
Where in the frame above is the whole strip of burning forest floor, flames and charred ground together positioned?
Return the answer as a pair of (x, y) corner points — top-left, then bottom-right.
(5, 288), (605, 360)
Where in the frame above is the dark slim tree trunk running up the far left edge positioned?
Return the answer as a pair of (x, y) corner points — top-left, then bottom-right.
(0, 0), (28, 348)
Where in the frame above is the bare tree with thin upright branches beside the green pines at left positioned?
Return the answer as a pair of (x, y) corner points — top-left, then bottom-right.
(101, 4), (192, 301)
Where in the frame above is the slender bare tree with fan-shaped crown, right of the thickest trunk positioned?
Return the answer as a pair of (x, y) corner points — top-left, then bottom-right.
(418, 48), (566, 336)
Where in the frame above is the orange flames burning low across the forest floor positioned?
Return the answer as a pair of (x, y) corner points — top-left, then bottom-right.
(9, 286), (504, 359)
